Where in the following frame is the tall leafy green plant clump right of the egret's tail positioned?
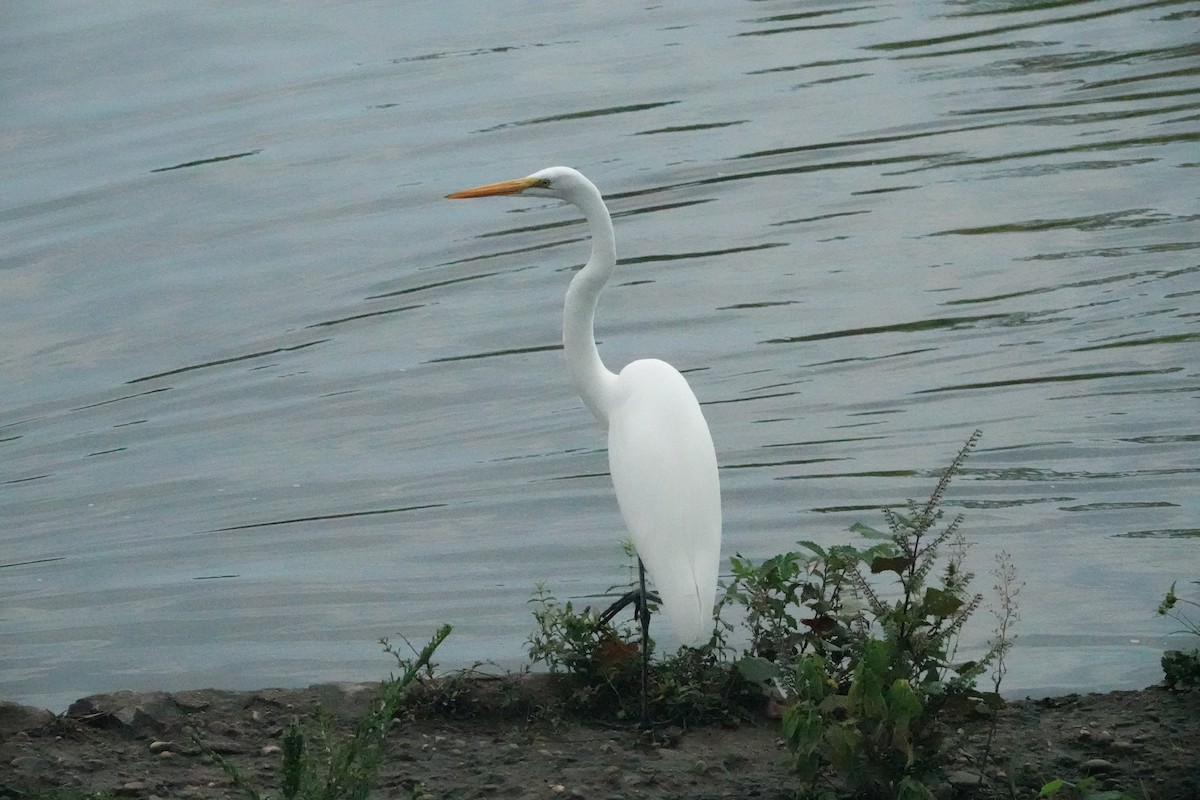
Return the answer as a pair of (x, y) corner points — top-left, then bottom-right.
(726, 432), (1020, 799)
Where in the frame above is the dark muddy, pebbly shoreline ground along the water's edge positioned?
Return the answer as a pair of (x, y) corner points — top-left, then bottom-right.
(0, 676), (1200, 800)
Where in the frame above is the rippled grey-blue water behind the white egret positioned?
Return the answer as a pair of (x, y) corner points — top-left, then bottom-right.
(0, 0), (1200, 709)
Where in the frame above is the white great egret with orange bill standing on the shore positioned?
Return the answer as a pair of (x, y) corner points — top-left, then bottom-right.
(446, 167), (721, 717)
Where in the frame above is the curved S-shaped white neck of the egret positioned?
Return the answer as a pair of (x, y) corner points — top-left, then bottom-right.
(563, 185), (617, 425)
